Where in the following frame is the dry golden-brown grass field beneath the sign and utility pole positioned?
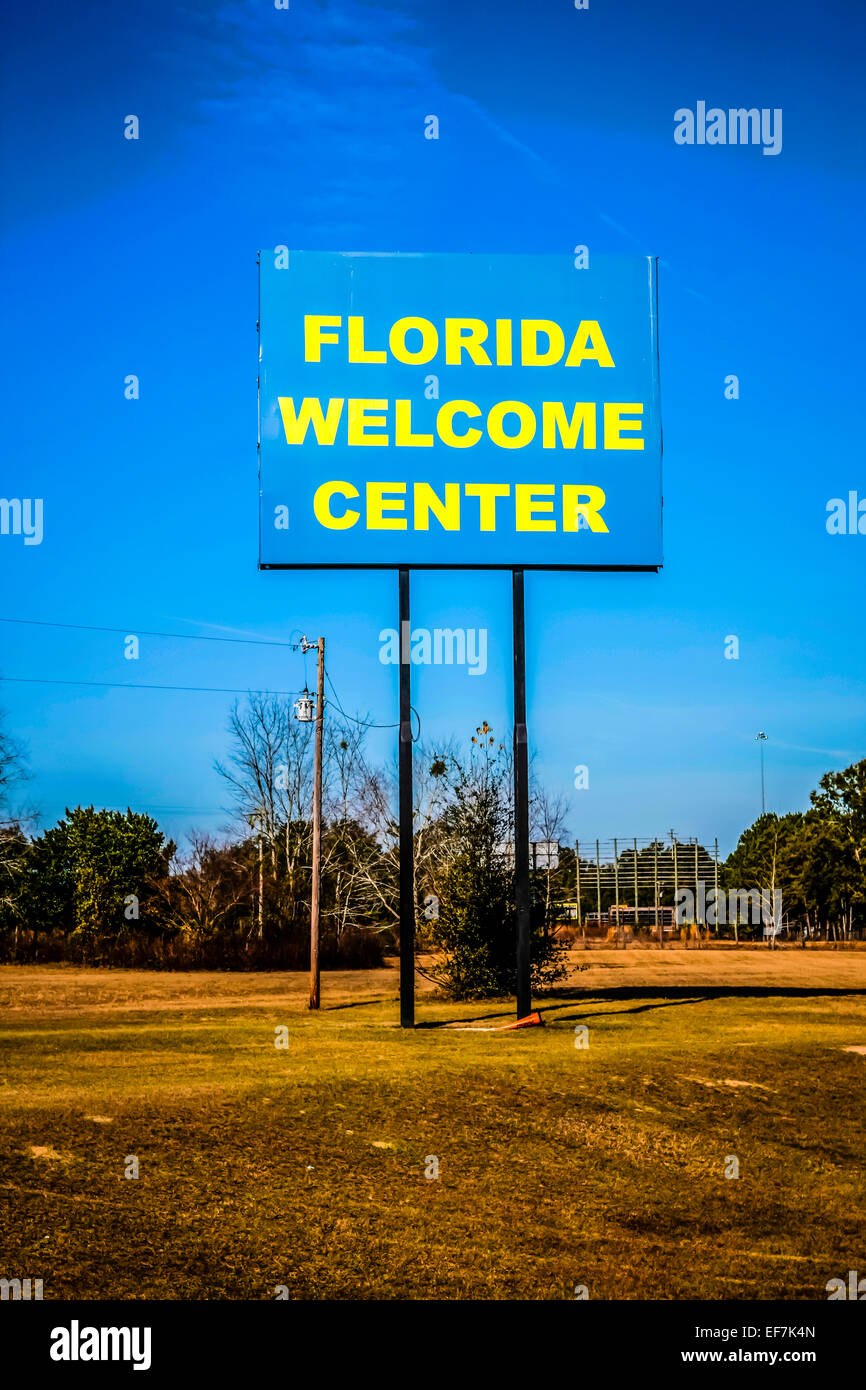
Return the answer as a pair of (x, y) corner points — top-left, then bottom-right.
(0, 948), (866, 1300)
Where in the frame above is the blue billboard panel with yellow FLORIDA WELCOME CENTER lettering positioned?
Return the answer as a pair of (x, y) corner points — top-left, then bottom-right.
(259, 247), (662, 569)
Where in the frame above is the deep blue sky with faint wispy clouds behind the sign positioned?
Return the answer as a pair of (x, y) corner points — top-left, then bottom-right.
(0, 0), (866, 849)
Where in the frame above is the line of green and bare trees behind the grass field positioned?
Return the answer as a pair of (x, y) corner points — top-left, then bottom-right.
(0, 695), (866, 998)
